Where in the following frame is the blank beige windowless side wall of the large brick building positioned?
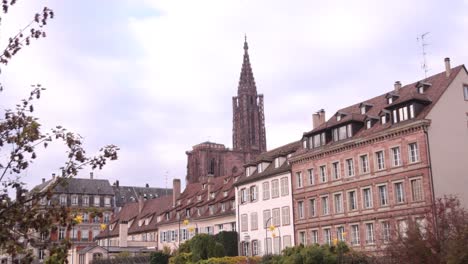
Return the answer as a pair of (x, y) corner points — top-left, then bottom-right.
(427, 69), (468, 208)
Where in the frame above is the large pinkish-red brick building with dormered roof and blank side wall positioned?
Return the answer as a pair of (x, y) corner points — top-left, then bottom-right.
(290, 58), (468, 250)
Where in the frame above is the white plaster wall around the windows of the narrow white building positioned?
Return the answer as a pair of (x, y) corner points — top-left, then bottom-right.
(236, 171), (295, 255)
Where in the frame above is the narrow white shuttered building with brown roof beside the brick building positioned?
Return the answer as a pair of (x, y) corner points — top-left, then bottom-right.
(234, 142), (300, 256)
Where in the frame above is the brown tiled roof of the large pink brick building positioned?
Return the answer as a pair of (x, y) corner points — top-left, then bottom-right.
(304, 65), (466, 141)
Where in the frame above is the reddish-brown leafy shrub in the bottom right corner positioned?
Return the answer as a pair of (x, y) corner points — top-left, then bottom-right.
(385, 196), (468, 264)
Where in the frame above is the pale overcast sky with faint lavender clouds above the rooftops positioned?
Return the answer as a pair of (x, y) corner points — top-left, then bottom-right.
(0, 0), (468, 190)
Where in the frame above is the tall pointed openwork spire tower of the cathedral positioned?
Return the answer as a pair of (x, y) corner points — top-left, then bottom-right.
(232, 38), (266, 154)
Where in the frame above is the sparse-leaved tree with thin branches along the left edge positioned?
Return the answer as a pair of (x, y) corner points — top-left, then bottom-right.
(0, 0), (118, 263)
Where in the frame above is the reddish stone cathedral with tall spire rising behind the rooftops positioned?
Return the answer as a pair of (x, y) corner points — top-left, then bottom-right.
(186, 37), (266, 183)
